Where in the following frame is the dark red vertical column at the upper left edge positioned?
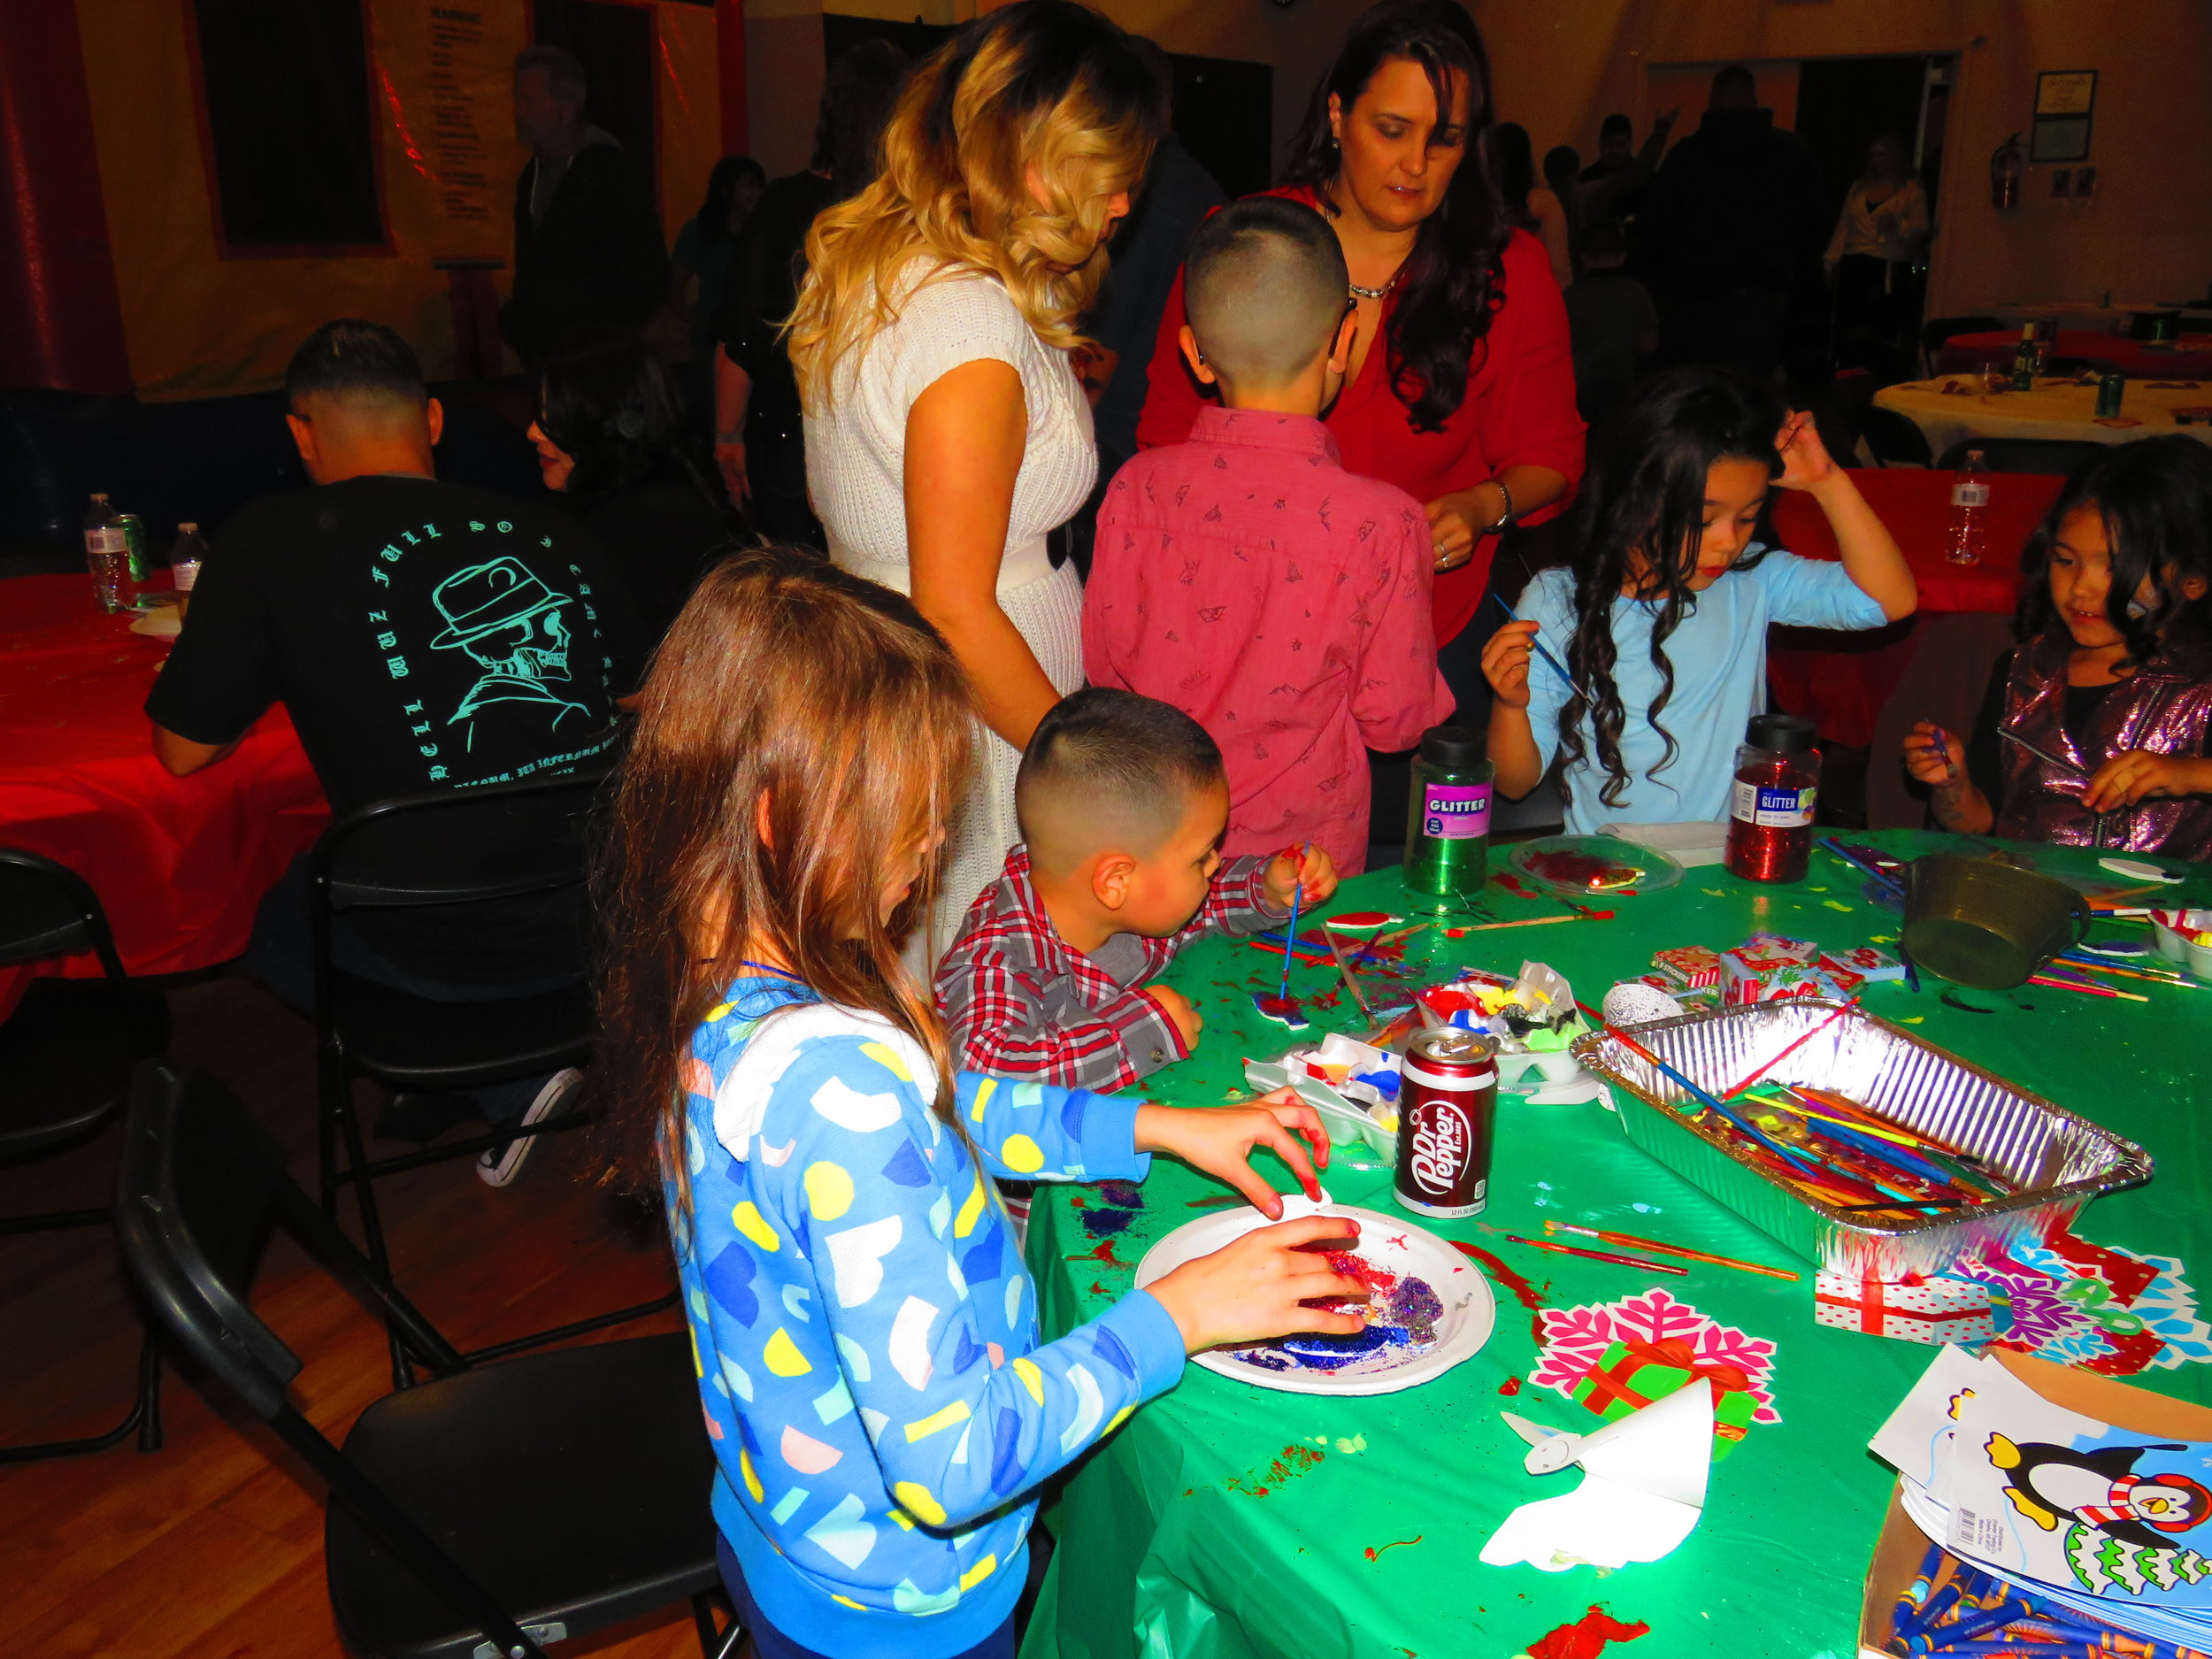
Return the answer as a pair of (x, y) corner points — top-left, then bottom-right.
(0, 0), (131, 392)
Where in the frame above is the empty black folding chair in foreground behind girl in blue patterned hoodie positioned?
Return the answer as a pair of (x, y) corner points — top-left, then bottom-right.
(115, 1062), (743, 1659)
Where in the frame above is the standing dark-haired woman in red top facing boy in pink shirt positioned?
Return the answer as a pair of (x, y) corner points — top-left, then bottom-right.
(1137, 0), (1582, 717)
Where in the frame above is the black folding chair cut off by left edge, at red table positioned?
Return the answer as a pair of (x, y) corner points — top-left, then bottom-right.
(0, 848), (168, 1464)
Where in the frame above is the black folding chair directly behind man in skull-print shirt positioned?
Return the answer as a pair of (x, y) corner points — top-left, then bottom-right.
(310, 772), (675, 1387)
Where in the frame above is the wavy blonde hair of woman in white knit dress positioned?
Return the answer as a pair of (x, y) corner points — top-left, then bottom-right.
(787, 0), (1168, 410)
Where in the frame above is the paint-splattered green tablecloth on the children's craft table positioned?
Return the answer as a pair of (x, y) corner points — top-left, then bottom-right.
(1022, 834), (2212, 1659)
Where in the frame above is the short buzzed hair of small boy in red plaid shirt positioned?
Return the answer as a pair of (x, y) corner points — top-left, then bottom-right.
(1013, 686), (1224, 874)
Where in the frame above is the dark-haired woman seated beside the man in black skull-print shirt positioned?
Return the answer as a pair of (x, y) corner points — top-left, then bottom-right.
(531, 327), (750, 641)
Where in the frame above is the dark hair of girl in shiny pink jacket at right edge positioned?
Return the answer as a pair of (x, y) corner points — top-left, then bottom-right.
(2016, 434), (2212, 671)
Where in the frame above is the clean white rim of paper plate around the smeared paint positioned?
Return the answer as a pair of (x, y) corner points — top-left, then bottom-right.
(1137, 1197), (1498, 1394)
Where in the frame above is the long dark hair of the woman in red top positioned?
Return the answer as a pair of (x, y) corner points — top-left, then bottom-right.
(1283, 0), (1513, 432)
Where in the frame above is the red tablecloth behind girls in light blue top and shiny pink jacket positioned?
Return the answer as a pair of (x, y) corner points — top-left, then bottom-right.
(1768, 467), (2064, 746)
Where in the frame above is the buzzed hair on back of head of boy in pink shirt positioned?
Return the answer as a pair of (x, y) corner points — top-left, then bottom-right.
(1184, 197), (1352, 388)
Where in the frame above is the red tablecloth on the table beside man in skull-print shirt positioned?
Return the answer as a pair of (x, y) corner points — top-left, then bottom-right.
(0, 575), (330, 1016)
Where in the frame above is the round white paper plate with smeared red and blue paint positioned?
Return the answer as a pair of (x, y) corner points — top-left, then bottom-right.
(1137, 1197), (1498, 1394)
